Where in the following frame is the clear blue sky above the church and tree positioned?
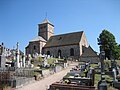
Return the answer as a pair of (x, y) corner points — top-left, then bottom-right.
(0, 0), (120, 52)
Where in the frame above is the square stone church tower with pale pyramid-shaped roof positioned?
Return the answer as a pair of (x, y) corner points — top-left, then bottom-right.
(38, 18), (54, 41)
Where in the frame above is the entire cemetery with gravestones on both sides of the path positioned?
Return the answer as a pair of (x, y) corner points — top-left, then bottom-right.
(0, 30), (120, 90)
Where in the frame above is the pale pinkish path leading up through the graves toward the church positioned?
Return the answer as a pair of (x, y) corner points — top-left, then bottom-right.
(16, 63), (77, 90)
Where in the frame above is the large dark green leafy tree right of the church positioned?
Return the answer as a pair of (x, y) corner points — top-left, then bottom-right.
(98, 30), (120, 59)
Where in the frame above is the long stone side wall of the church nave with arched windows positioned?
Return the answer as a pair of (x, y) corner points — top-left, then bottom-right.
(44, 45), (80, 58)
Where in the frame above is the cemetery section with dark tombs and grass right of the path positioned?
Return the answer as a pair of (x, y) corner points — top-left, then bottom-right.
(49, 52), (120, 90)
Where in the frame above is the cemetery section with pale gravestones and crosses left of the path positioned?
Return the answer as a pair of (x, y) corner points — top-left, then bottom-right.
(0, 43), (68, 90)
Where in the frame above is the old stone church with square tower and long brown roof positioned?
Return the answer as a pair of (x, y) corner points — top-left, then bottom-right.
(26, 19), (98, 59)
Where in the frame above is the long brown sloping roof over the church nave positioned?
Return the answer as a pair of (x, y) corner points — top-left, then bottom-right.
(45, 31), (83, 47)
